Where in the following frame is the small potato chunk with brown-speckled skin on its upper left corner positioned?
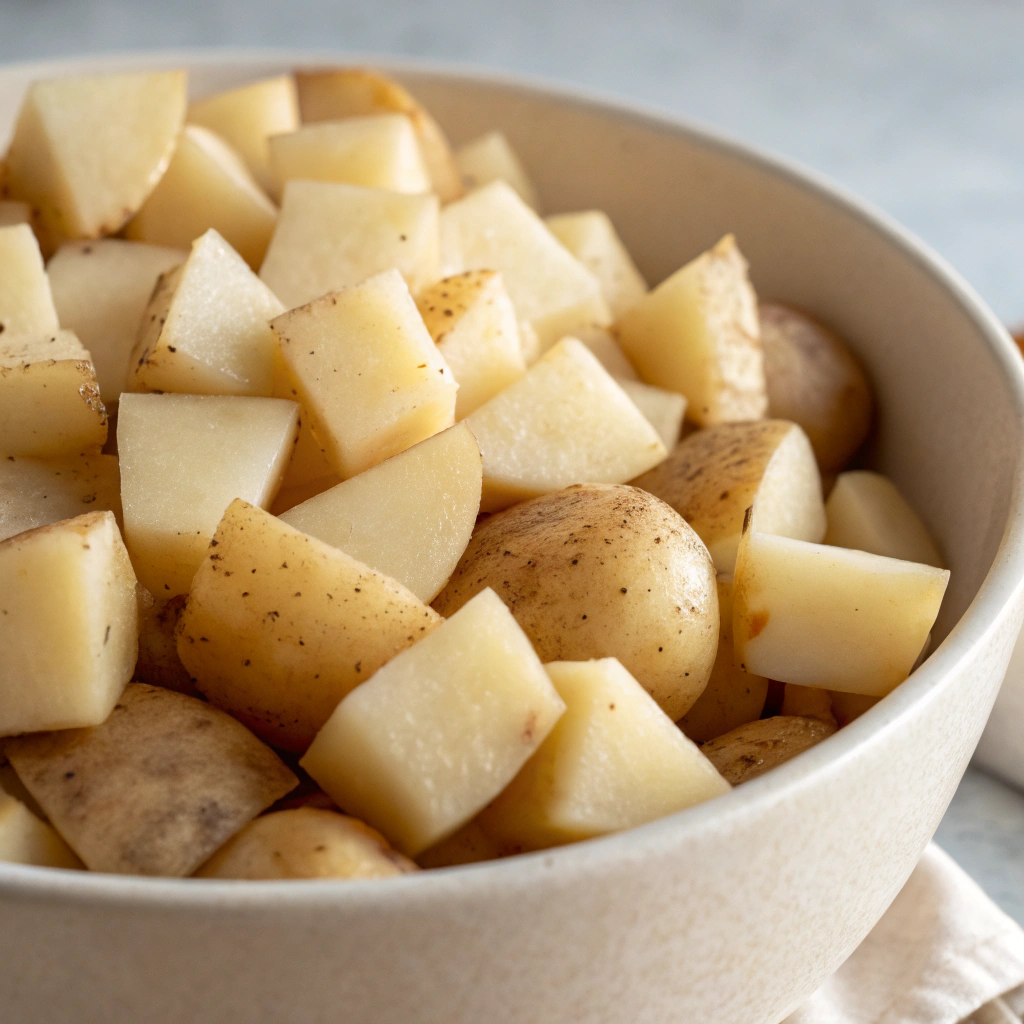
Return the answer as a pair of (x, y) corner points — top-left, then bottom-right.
(416, 270), (526, 420)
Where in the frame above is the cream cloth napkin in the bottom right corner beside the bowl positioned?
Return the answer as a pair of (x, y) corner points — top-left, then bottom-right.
(784, 844), (1024, 1024)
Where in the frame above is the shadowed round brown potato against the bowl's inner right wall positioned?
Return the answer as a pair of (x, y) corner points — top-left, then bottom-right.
(760, 302), (874, 473)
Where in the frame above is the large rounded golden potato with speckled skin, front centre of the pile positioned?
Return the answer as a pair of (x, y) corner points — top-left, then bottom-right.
(434, 483), (719, 720)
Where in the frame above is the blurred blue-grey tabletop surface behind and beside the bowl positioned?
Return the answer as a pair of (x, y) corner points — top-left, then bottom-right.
(0, 0), (1024, 924)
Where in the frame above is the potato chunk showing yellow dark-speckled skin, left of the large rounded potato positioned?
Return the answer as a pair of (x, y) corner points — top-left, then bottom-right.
(178, 501), (441, 753)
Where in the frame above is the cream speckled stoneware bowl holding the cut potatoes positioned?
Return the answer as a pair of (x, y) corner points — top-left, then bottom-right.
(0, 53), (1024, 1024)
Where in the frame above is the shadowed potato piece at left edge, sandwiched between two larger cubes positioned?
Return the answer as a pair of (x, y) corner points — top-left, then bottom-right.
(0, 455), (121, 541)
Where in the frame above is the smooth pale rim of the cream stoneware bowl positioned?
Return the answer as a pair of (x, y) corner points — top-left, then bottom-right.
(0, 47), (1024, 910)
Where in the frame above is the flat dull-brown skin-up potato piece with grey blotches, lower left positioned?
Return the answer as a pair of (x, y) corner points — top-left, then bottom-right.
(7, 683), (298, 878)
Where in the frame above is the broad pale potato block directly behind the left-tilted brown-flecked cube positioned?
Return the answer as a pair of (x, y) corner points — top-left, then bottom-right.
(260, 181), (440, 308)
